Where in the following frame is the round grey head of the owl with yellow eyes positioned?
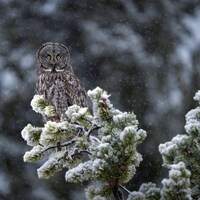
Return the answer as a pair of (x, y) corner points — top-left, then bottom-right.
(36, 42), (72, 73)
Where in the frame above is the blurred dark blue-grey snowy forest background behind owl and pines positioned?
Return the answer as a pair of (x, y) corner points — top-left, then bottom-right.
(0, 0), (200, 200)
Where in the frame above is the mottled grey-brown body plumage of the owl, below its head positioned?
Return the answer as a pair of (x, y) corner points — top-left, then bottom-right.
(36, 73), (87, 117)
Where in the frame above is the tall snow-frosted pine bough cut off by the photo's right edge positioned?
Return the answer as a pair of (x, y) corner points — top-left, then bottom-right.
(159, 91), (200, 200)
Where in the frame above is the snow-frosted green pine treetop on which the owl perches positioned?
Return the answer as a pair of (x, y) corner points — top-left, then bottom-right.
(22, 87), (146, 199)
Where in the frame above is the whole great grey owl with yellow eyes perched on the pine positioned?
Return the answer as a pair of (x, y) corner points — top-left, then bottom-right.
(36, 42), (87, 120)
